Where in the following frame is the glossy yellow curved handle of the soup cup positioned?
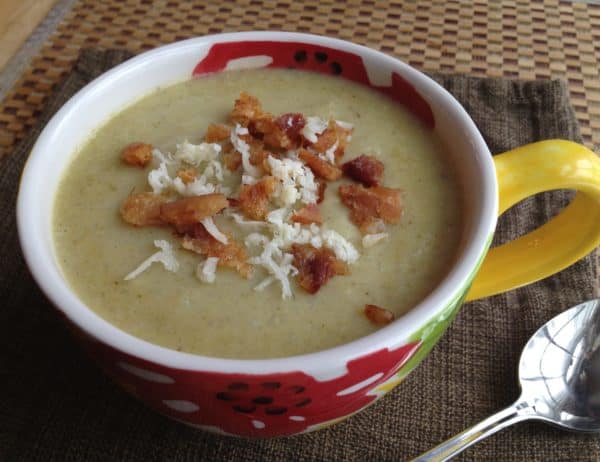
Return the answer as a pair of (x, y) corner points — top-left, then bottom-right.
(467, 140), (600, 300)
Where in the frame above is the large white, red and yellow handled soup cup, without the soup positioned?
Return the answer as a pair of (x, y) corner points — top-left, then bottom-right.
(17, 32), (600, 437)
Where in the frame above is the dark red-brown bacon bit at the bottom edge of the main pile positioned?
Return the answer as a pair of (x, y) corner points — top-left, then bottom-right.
(291, 244), (348, 294)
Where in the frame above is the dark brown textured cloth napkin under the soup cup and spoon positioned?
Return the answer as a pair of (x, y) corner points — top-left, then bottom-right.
(0, 50), (600, 462)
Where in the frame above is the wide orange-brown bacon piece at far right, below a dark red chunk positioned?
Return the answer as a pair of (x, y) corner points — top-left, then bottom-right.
(339, 184), (402, 233)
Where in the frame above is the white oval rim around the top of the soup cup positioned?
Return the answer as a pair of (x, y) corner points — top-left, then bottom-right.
(17, 31), (498, 375)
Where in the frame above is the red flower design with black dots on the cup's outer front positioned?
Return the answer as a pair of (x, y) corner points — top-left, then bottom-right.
(88, 334), (420, 437)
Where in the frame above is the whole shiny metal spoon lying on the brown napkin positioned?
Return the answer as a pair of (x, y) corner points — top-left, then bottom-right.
(414, 299), (600, 461)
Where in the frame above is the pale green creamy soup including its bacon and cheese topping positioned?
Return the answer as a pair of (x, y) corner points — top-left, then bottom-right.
(53, 69), (461, 358)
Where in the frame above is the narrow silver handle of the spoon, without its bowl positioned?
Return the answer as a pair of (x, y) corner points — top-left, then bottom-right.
(413, 401), (532, 462)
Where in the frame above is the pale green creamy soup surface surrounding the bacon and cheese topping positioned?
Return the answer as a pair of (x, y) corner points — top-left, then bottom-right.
(54, 70), (461, 358)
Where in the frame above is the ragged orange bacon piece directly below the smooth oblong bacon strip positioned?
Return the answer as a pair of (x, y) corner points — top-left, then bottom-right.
(181, 223), (253, 279)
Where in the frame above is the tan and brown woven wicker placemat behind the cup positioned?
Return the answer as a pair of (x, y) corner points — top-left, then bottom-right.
(0, 0), (600, 161)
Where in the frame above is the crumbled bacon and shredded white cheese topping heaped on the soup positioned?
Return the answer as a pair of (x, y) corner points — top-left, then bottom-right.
(121, 92), (402, 304)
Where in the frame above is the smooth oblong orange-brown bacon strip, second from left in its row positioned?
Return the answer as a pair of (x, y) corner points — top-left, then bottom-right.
(160, 193), (229, 225)
